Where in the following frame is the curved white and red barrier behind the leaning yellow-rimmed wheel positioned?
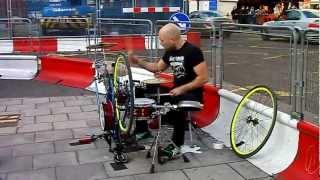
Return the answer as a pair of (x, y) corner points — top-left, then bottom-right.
(203, 89), (320, 180)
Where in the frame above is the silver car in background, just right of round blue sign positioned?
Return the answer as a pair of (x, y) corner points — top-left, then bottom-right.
(189, 11), (232, 37)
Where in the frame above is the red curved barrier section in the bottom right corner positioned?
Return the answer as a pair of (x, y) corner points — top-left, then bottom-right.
(277, 120), (320, 180)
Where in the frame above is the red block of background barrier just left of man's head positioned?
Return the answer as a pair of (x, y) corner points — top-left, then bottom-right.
(101, 35), (146, 51)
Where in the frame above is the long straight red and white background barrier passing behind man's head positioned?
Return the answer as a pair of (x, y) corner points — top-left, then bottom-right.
(0, 32), (200, 54)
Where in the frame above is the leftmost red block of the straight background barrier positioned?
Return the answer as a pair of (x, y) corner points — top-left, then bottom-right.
(13, 37), (58, 53)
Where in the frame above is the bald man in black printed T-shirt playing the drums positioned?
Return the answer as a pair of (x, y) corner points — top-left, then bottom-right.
(129, 23), (208, 157)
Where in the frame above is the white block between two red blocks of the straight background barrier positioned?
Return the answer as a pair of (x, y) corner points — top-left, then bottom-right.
(57, 38), (101, 52)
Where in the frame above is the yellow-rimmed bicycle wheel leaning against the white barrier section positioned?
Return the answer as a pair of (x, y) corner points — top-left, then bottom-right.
(230, 85), (277, 158)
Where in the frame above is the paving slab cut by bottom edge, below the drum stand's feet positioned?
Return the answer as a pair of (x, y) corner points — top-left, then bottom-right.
(134, 171), (188, 180)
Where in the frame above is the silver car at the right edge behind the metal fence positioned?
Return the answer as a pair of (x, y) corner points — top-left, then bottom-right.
(262, 9), (319, 40)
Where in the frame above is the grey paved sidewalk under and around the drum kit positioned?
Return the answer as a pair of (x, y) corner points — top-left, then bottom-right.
(0, 96), (273, 180)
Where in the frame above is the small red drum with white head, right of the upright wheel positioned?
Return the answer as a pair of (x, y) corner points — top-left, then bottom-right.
(134, 98), (155, 121)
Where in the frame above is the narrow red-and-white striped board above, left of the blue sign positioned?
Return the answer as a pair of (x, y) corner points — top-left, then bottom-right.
(122, 7), (180, 14)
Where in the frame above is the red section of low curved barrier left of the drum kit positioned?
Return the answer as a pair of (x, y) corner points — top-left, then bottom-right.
(36, 56), (95, 89)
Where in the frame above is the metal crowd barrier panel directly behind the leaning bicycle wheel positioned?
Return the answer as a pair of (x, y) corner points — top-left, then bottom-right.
(216, 24), (303, 119)
